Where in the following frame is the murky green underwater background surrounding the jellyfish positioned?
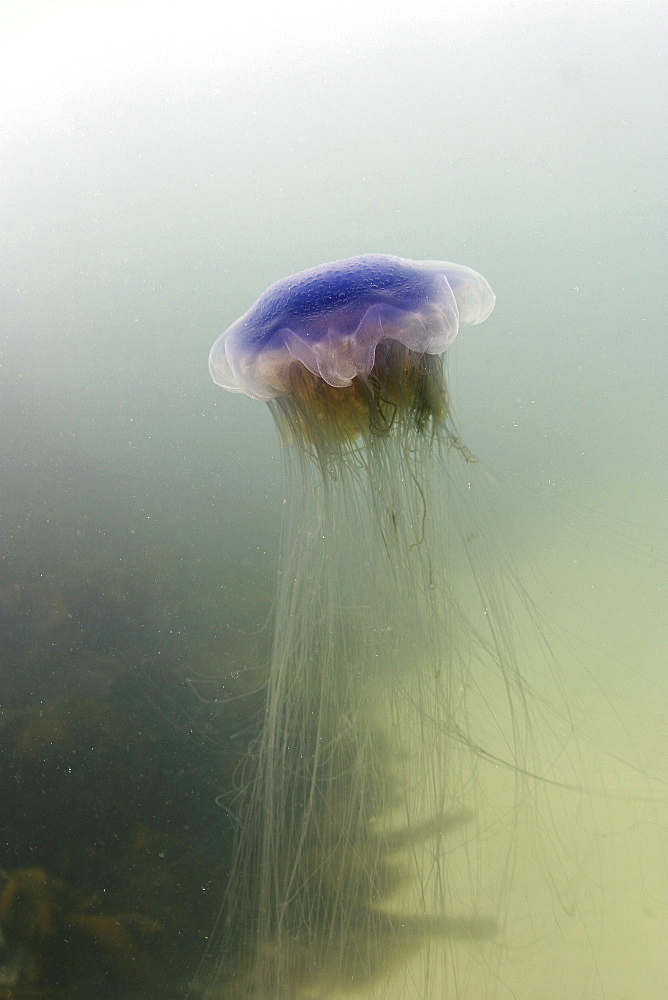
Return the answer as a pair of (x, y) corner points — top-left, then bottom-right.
(0, 3), (668, 1000)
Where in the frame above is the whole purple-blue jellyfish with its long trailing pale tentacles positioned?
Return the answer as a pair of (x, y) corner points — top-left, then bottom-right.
(204, 254), (523, 1000)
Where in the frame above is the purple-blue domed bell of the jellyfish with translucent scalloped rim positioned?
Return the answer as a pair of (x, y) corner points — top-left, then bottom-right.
(209, 254), (495, 400)
